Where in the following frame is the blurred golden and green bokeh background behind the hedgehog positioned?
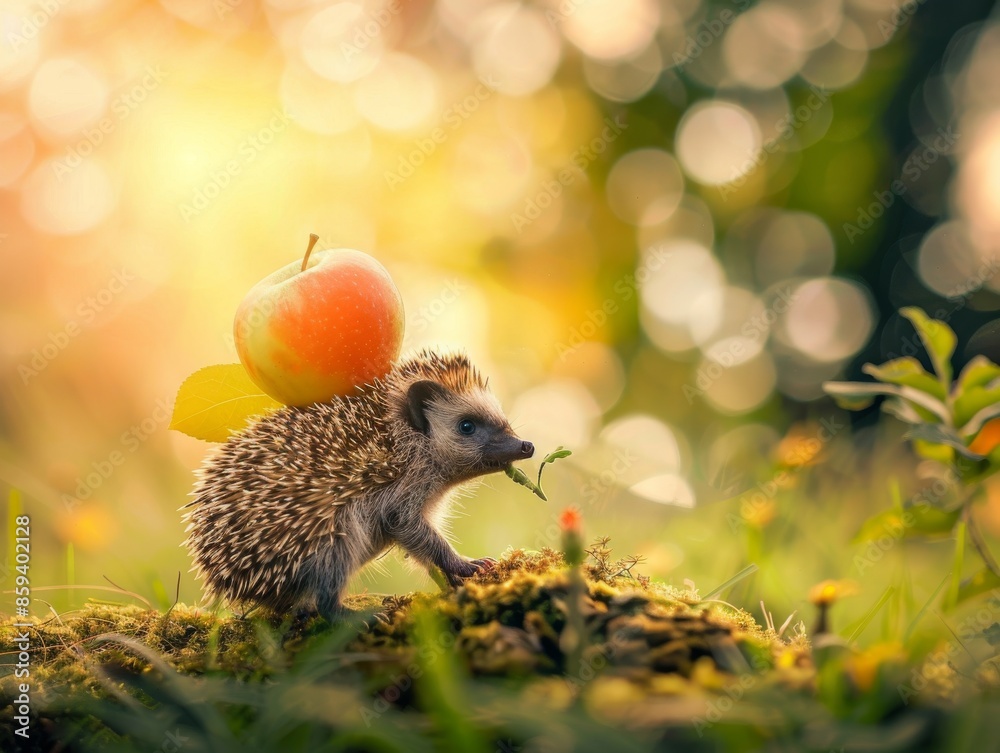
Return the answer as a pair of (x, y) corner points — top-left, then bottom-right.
(0, 0), (1000, 632)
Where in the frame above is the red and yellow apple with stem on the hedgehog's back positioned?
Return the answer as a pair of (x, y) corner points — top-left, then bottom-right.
(233, 235), (404, 405)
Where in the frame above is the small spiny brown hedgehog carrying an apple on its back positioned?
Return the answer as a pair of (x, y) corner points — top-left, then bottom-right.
(181, 350), (534, 619)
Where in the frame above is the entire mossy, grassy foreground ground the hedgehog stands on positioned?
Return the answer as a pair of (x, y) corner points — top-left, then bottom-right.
(0, 541), (1000, 753)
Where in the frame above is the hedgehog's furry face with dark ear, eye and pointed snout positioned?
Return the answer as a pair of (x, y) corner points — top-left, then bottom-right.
(407, 380), (535, 480)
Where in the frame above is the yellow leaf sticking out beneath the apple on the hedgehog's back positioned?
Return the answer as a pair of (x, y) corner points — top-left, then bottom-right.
(170, 363), (283, 442)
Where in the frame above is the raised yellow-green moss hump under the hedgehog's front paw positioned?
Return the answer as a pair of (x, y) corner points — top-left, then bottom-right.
(354, 549), (809, 682)
